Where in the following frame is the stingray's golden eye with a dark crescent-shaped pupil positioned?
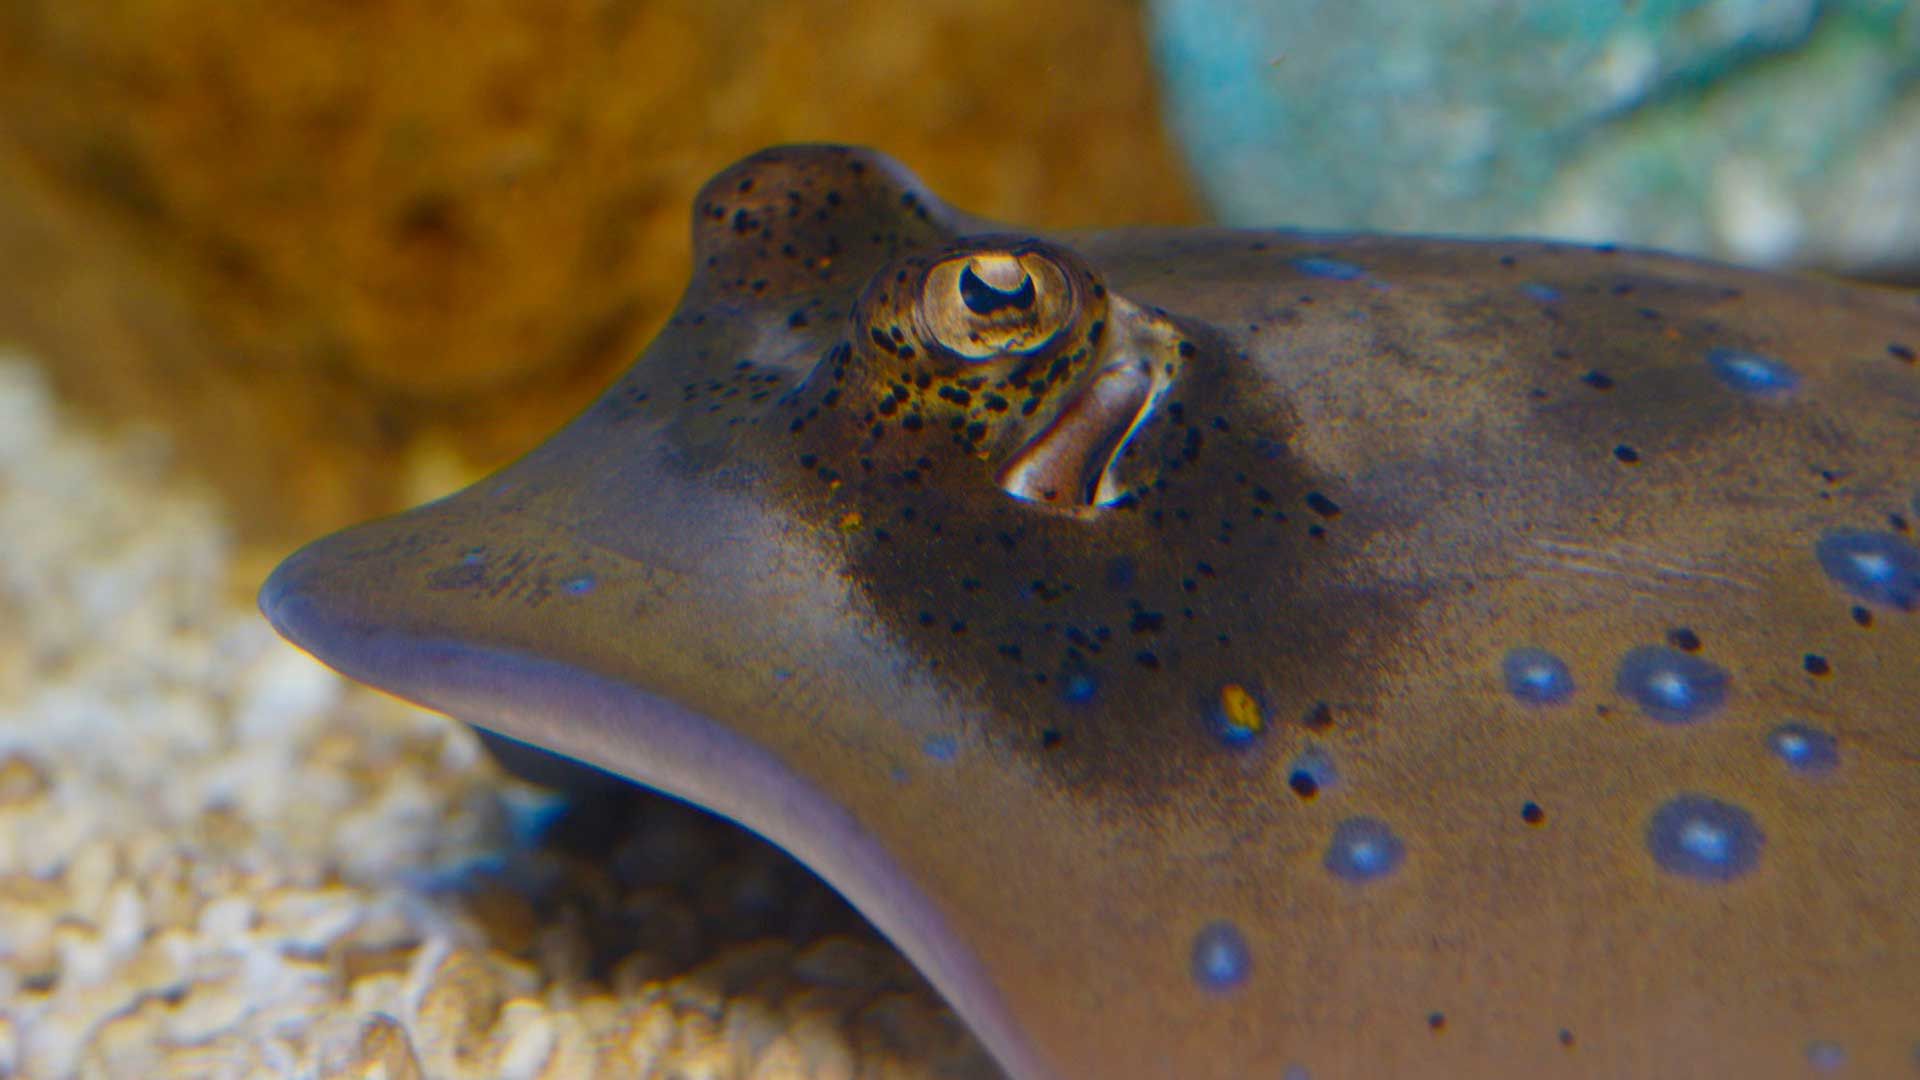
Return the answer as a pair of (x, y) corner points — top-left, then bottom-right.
(920, 252), (1073, 361)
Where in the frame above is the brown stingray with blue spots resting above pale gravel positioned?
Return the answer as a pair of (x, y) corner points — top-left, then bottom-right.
(263, 148), (1920, 1080)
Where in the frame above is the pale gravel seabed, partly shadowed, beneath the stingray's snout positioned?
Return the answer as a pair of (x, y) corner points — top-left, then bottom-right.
(0, 354), (995, 1080)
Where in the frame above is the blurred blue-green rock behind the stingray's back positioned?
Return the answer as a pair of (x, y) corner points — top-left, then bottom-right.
(1150, 0), (1920, 269)
